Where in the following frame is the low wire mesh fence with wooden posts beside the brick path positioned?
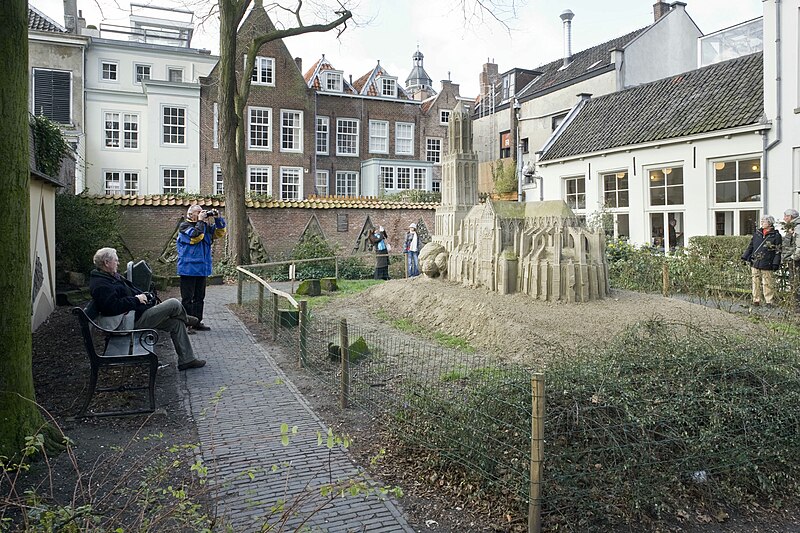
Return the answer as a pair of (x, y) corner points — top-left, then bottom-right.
(234, 258), (800, 531)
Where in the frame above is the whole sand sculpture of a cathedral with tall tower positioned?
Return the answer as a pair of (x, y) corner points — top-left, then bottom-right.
(420, 103), (608, 302)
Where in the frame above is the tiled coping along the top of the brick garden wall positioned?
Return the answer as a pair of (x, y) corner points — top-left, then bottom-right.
(84, 194), (439, 209)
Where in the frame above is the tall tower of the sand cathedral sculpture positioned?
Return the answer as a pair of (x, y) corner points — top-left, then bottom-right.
(433, 102), (478, 252)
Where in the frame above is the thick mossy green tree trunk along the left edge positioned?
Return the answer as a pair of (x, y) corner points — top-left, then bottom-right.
(0, 0), (44, 457)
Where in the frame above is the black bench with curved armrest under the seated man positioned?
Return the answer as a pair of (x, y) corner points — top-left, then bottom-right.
(72, 303), (159, 417)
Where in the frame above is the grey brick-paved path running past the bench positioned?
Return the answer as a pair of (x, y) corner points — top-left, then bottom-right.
(181, 286), (414, 533)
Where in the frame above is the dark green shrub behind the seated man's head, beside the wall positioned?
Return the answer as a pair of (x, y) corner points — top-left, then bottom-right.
(56, 193), (124, 274)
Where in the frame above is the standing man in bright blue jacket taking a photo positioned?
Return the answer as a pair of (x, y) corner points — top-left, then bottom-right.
(177, 204), (226, 333)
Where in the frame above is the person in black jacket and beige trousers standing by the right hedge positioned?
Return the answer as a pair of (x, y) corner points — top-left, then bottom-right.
(742, 215), (782, 306)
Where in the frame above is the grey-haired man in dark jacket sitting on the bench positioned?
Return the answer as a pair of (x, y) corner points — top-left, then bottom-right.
(89, 248), (206, 370)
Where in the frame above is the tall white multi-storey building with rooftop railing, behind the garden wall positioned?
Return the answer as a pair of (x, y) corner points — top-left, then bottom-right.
(84, 4), (217, 195)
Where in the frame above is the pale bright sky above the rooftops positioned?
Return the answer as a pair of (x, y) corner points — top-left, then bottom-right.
(29, 0), (762, 97)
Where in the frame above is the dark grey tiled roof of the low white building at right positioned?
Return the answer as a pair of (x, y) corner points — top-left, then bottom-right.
(540, 52), (764, 160)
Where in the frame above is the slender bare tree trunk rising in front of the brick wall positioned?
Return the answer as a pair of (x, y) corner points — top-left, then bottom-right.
(218, 0), (250, 265)
